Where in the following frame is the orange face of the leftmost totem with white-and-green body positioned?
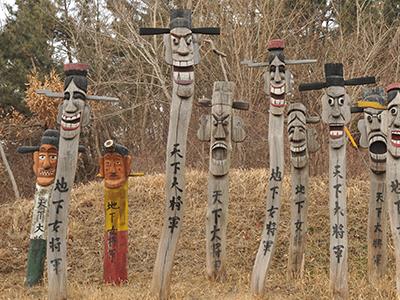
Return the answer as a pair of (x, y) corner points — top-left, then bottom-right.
(33, 144), (58, 186)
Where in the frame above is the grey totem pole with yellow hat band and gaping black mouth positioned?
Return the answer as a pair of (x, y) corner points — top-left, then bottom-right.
(352, 88), (387, 283)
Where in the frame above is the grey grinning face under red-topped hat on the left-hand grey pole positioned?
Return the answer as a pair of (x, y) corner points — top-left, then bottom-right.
(57, 80), (90, 140)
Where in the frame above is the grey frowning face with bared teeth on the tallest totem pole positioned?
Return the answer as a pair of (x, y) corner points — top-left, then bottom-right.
(164, 27), (198, 98)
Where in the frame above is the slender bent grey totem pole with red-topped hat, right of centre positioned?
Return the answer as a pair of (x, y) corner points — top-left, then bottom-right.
(244, 40), (316, 295)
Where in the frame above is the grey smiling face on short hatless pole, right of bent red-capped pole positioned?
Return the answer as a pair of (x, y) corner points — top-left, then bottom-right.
(288, 110), (308, 168)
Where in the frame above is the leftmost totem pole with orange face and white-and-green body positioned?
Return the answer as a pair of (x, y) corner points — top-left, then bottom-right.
(17, 129), (60, 287)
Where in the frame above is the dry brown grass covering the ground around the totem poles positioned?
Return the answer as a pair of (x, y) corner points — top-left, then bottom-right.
(0, 170), (395, 300)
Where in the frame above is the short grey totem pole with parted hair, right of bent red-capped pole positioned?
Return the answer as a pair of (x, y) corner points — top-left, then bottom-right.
(287, 103), (319, 278)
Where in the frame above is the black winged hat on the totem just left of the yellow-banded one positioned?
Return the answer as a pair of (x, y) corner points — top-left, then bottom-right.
(299, 63), (376, 91)
